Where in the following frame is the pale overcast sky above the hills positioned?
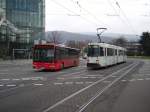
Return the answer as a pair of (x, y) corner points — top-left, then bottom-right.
(46, 0), (150, 35)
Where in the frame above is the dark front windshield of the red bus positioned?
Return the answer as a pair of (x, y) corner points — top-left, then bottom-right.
(33, 48), (54, 62)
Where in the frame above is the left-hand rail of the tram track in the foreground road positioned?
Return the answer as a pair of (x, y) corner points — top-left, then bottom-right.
(43, 63), (136, 112)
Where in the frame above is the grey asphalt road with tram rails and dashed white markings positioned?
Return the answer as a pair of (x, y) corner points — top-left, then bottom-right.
(0, 59), (150, 112)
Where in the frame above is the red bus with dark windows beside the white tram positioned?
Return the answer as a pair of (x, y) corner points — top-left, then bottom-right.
(33, 44), (80, 70)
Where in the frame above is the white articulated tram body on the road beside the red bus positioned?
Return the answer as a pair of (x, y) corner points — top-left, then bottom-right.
(87, 43), (127, 68)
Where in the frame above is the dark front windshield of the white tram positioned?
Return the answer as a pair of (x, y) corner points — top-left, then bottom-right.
(88, 45), (99, 57)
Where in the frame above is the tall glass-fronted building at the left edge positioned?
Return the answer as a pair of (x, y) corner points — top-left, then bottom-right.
(0, 0), (45, 58)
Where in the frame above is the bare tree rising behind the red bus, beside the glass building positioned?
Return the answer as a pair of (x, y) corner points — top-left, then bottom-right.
(48, 31), (62, 44)
